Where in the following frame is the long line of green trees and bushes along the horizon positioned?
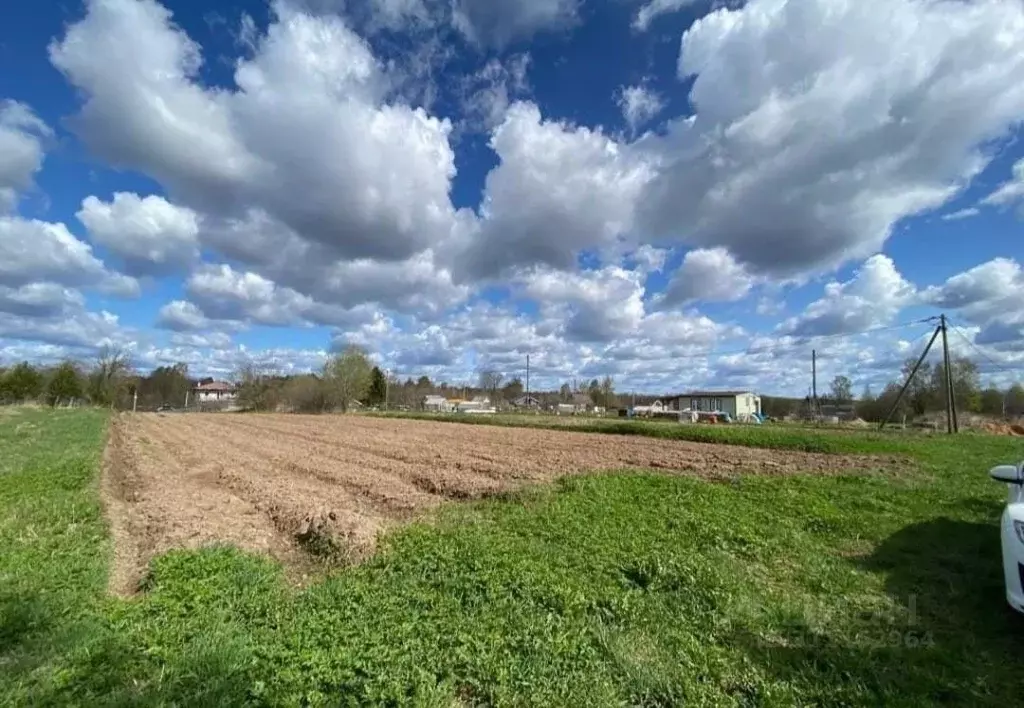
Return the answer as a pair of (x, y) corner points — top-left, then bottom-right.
(6, 346), (1024, 422)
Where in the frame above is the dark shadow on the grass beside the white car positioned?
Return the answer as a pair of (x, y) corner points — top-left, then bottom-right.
(734, 518), (1024, 705)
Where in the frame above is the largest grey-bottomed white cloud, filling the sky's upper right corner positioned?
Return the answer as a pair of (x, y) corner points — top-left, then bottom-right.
(639, 0), (1024, 278)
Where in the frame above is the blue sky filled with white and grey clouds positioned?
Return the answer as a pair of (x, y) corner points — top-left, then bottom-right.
(0, 0), (1024, 394)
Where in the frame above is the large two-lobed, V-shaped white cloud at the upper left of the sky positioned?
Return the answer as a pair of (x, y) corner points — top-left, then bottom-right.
(50, 0), (455, 260)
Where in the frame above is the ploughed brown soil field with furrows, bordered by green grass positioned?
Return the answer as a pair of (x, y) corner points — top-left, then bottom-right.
(102, 414), (895, 593)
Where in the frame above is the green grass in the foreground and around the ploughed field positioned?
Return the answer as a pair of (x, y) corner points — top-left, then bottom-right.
(0, 411), (1024, 706)
